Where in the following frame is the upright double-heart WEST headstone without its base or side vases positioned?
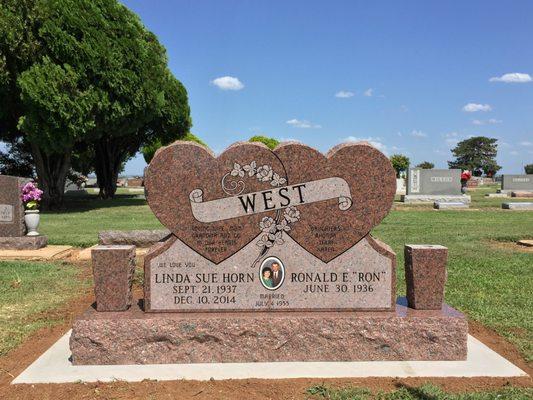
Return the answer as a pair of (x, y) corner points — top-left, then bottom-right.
(145, 142), (396, 312)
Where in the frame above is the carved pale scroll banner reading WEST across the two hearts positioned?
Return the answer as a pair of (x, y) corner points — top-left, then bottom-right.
(189, 177), (352, 222)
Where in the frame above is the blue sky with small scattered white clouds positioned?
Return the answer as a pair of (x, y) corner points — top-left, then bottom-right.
(124, 0), (533, 174)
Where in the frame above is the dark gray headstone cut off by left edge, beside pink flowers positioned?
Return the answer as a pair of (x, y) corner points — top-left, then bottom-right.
(0, 175), (28, 237)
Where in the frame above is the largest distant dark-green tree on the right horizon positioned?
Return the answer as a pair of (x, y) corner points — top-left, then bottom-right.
(448, 136), (501, 176)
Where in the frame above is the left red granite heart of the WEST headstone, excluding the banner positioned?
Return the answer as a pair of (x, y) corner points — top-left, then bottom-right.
(145, 142), (287, 264)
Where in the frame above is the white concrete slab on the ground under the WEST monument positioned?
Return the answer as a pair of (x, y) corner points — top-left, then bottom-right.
(11, 332), (527, 384)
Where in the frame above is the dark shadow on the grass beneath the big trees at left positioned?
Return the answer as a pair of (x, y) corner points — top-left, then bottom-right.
(43, 194), (147, 214)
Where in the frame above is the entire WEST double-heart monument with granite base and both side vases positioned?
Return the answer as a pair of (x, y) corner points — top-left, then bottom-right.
(70, 142), (467, 364)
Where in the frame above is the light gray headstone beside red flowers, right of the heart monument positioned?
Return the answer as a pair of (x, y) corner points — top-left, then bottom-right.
(407, 168), (461, 195)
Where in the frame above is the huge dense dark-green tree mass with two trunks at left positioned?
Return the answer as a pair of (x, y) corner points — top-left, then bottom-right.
(0, 0), (191, 206)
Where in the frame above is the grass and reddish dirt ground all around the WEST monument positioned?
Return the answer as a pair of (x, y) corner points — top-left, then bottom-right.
(0, 187), (533, 399)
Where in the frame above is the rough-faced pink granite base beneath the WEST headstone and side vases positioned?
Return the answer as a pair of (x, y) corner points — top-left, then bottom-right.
(70, 299), (468, 365)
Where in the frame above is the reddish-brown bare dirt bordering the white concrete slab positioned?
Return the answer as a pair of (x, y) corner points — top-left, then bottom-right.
(0, 264), (533, 400)
